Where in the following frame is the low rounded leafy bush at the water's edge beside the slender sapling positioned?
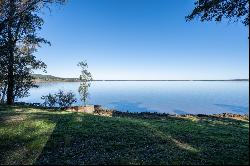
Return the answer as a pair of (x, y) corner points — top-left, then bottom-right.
(41, 90), (77, 108)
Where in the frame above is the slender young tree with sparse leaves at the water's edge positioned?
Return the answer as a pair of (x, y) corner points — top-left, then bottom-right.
(78, 61), (93, 106)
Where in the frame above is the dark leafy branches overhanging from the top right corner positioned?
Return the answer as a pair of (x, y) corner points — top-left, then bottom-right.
(186, 0), (249, 26)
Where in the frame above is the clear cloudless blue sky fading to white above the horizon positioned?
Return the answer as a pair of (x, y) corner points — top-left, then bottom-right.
(36, 0), (249, 79)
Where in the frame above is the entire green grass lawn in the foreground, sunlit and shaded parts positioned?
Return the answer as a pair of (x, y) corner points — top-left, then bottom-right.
(0, 106), (249, 165)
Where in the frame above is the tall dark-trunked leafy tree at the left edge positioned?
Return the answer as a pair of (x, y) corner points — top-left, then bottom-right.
(0, 0), (65, 105)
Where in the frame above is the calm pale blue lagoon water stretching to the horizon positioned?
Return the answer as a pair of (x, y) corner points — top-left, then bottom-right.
(19, 81), (249, 114)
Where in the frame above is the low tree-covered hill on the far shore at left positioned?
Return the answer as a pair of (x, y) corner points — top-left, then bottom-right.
(32, 74), (79, 82)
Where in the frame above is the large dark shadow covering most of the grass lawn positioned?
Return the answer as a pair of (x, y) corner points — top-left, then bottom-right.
(35, 110), (249, 165)
